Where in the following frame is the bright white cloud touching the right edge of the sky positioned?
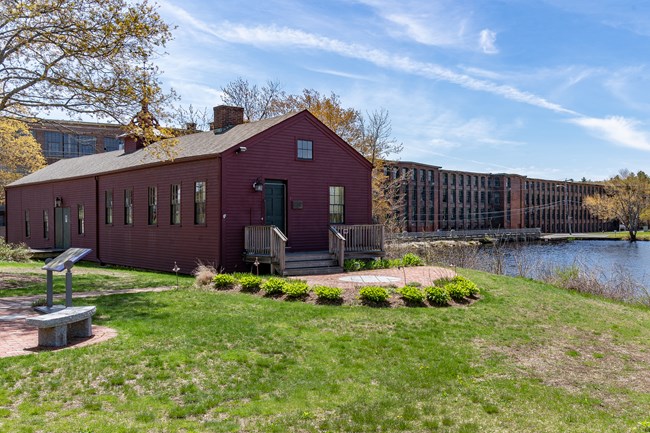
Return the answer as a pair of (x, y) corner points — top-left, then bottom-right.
(569, 116), (650, 152)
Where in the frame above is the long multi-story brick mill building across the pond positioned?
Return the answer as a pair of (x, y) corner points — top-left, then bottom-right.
(385, 161), (612, 233)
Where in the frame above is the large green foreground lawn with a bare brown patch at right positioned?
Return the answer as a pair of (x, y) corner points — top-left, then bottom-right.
(0, 264), (650, 433)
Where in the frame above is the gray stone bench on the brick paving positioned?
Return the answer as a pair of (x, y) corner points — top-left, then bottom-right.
(25, 306), (97, 347)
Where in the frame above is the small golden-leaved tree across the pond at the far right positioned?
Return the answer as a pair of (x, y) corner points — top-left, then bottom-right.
(585, 170), (650, 241)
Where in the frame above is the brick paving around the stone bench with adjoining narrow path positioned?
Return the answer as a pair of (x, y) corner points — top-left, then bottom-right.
(0, 287), (172, 358)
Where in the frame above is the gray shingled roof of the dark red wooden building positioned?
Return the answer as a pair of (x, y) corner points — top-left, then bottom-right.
(8, 113), (297, 186)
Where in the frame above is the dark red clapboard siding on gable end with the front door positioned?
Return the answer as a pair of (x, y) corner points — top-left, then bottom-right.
(222, 115), (372, 269)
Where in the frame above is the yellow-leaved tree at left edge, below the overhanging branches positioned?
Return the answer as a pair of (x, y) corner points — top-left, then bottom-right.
(0, 117), (45, 203)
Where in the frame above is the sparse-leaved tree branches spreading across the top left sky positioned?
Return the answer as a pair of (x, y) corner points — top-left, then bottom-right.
(0, 0), (171, 123)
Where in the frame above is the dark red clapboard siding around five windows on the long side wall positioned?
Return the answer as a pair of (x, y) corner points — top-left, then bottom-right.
(99, 158), (220, 273)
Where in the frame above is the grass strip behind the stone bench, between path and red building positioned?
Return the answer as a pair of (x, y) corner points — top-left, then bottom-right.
(0, 262), (194, 297)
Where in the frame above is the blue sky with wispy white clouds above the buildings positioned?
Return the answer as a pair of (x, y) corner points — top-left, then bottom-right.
(156, 0), (650, 180)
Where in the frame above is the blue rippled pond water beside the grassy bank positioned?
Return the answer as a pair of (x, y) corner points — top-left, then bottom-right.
(483, 240), (650, 287)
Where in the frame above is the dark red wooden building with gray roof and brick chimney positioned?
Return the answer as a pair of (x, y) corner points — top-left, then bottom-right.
(6, 106), (383, 273)
